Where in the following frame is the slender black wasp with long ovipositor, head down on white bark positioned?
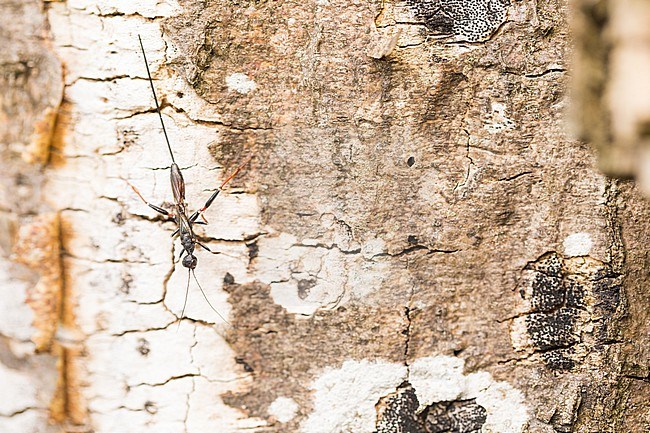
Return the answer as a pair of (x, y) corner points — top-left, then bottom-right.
(129, 35), (252, 326)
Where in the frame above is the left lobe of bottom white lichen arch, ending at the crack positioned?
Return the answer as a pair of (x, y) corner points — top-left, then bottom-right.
(302, 360), (407, 433)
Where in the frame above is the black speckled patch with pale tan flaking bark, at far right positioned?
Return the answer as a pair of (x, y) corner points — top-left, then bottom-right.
(519, 252), (621, 370)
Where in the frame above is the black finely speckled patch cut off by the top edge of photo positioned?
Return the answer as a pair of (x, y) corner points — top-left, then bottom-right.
(406, 0), (510, 42)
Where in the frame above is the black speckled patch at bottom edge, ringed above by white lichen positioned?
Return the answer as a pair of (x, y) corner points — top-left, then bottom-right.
(375, 384), (487, 433)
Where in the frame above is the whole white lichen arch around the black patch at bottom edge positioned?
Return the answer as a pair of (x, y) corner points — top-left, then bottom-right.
(302, 356), (529, 433)
